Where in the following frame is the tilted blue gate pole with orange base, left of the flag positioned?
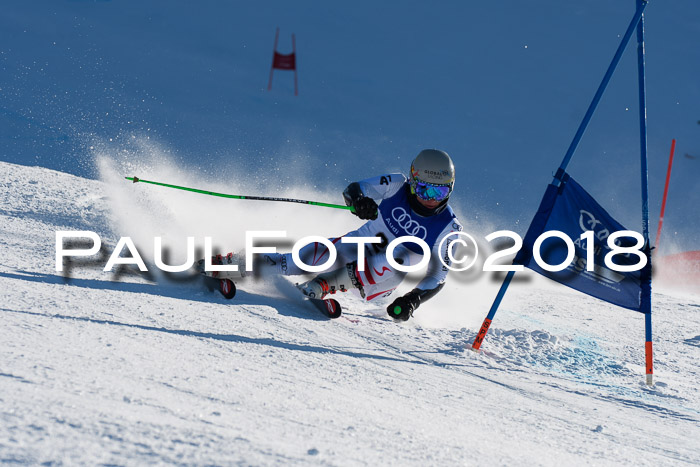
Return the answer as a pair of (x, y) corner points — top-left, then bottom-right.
(472, 0), (651, 351)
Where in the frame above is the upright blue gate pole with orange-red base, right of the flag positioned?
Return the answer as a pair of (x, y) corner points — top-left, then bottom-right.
(636, 0), (654, 386)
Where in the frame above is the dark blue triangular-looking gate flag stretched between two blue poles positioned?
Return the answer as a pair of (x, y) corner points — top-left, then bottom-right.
(513, 173), (641, 311)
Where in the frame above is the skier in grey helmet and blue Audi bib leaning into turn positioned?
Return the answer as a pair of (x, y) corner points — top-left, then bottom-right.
(200, 149), (462, 321)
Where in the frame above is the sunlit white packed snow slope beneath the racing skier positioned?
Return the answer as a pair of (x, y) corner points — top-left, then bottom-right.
(0, 162), (700, 466)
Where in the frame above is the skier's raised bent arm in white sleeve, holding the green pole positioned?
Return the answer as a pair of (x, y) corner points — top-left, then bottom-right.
(343, 174), (406, 220)
